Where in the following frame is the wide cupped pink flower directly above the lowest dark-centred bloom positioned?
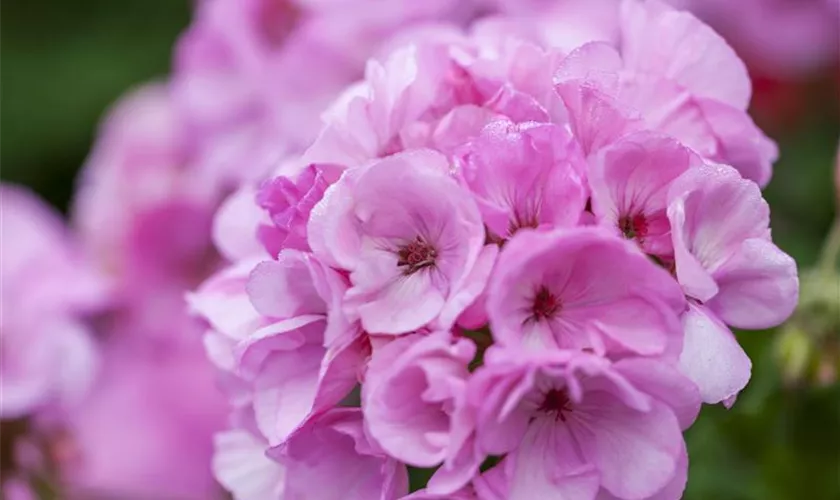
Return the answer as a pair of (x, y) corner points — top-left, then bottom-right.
(487, 228), (685, 354)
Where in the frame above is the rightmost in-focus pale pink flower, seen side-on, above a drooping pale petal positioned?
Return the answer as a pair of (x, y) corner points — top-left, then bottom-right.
(668, 165), (799, 329)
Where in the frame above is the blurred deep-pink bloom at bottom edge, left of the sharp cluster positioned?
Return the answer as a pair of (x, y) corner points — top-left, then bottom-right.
(59, 337), (226, 500)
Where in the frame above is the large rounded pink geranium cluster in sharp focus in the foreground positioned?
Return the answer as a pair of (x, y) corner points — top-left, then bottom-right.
(190, 0), (798, 500)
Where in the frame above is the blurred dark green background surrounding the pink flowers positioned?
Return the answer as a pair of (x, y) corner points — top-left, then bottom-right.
(0, 0), (840, 500)
